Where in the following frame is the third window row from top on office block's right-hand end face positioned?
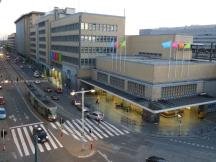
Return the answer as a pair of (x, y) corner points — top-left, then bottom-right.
(80, 47), (116, 53)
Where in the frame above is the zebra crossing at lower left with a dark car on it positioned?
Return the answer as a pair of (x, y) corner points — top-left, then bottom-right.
(10, 122), (63, 157)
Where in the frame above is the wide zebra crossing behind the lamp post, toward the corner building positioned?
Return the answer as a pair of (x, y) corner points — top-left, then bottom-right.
(50, 119), (130, 142)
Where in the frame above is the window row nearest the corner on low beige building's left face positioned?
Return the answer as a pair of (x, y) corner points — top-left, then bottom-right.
(128, 81), (145, 97)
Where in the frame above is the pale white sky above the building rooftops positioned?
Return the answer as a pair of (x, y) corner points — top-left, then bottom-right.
(0, 0), (216, 39)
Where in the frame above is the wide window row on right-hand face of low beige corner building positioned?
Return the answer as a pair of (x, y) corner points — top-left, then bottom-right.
(161, 84), (197, 98)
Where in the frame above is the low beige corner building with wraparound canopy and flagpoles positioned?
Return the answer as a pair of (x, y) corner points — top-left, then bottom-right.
(81, 35), (216, 121)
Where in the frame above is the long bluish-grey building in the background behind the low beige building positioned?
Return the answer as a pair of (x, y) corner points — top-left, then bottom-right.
(139, 25), (216, 45)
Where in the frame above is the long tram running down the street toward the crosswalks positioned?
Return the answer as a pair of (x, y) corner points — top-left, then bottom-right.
(27, 84), (57, 121)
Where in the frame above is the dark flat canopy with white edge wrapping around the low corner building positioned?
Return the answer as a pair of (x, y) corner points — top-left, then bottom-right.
(80, 78), (216, 114)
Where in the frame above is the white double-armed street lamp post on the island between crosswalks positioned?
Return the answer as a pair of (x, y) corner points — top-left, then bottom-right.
(70, 88), (95, 150)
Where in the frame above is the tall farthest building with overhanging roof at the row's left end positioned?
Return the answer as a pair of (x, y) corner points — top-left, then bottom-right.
(15, 11), (44, 57)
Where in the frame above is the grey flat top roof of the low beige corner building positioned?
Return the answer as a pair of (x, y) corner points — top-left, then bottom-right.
(101, 55), (214, 65)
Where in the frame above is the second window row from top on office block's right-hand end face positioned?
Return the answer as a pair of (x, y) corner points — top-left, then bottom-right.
(81, 35), (117, 42)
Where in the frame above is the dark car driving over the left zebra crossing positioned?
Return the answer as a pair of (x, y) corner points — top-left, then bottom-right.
(32, 127), (49, 143)
